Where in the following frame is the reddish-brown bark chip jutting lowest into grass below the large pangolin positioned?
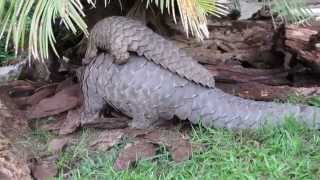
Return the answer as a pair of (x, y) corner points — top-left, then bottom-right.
(114, 141), (157, 171)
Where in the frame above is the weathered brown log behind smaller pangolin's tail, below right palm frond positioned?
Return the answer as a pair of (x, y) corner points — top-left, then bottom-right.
(173, 20), (282, 68)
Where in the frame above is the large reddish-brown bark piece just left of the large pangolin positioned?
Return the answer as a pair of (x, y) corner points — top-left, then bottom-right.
(28, 84), (81, 119)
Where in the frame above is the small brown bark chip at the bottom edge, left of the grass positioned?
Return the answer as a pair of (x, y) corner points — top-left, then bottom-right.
(32, 161), (58, 180)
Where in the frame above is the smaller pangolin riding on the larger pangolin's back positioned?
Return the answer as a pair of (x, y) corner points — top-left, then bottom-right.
(83, 16), (214, 88)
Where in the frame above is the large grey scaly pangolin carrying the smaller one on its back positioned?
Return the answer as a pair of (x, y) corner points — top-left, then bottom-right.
(82, 53), (320, 129)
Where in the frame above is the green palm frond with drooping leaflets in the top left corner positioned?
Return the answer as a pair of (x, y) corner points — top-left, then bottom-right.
(0, 0), (89, 60)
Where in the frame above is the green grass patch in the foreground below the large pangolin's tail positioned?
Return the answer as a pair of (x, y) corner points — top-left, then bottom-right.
(52, 119), (320, 180)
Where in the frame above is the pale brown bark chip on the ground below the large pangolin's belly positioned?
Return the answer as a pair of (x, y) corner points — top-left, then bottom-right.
(90, 129), (124, 151)
